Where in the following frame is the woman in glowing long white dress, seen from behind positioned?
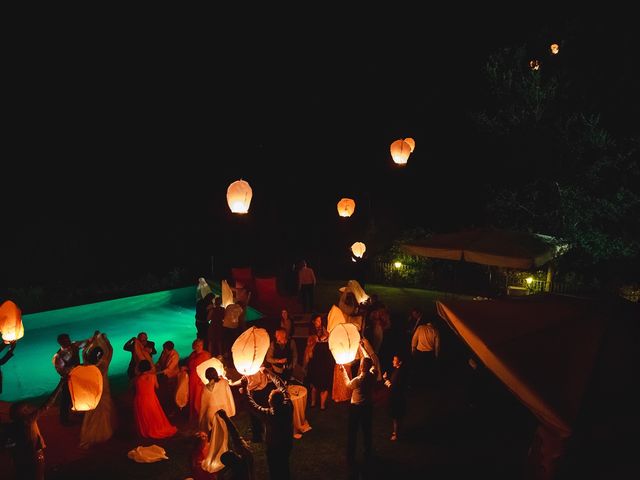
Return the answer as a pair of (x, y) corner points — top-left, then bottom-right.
(199, 367), (236, 472)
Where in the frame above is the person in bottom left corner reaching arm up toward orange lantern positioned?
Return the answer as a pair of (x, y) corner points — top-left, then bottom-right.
(5, 374), (68, 480)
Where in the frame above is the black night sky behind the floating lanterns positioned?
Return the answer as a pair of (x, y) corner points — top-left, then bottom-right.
(0, 11), (638, 287)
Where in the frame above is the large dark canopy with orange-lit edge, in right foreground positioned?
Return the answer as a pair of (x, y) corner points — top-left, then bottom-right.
(437, 295), (606, 437)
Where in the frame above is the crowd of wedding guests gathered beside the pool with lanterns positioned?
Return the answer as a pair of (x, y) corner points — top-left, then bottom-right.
(0, 272), (440, 480)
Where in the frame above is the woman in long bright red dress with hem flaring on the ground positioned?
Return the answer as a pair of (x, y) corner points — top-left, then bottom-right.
(133, 360), (178, 438)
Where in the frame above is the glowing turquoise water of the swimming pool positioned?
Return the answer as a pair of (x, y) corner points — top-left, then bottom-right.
(0, 287), (261, 402)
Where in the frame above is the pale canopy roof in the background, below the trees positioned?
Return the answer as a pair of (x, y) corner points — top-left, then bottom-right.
(402, 229), (562, 270)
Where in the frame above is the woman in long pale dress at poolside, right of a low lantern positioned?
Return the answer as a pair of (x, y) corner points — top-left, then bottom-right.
(80, 332), (116, 448)
